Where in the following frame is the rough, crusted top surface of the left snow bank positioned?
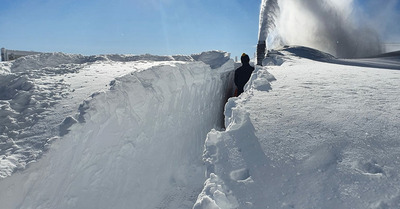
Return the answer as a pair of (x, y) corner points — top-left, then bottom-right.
(0, 51), (233, 178)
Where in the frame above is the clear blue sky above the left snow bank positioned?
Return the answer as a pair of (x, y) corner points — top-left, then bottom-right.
(0, 0), (400, 57)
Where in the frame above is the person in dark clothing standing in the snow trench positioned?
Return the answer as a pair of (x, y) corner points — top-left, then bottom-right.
(235, 53), (254, 96)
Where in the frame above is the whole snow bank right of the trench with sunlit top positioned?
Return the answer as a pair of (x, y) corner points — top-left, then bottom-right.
(194, 48), (400, 209)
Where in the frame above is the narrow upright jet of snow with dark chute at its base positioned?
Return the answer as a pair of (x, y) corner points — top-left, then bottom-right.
(257, 0), (279, 65)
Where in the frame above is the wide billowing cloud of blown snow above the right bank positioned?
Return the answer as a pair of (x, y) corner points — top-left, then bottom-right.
(274, 0), (382, 58)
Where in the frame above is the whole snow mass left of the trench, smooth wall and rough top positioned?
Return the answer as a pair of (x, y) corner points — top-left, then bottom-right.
(0, 51), (234, 208)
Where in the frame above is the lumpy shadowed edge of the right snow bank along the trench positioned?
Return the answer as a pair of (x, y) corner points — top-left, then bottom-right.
(194, 66), (275, 209)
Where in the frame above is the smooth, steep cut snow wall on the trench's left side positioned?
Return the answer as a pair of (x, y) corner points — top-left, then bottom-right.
(0, 52), (234, 209)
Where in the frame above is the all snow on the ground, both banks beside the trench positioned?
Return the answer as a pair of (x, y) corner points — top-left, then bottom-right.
(0, 46), (400, 209)
